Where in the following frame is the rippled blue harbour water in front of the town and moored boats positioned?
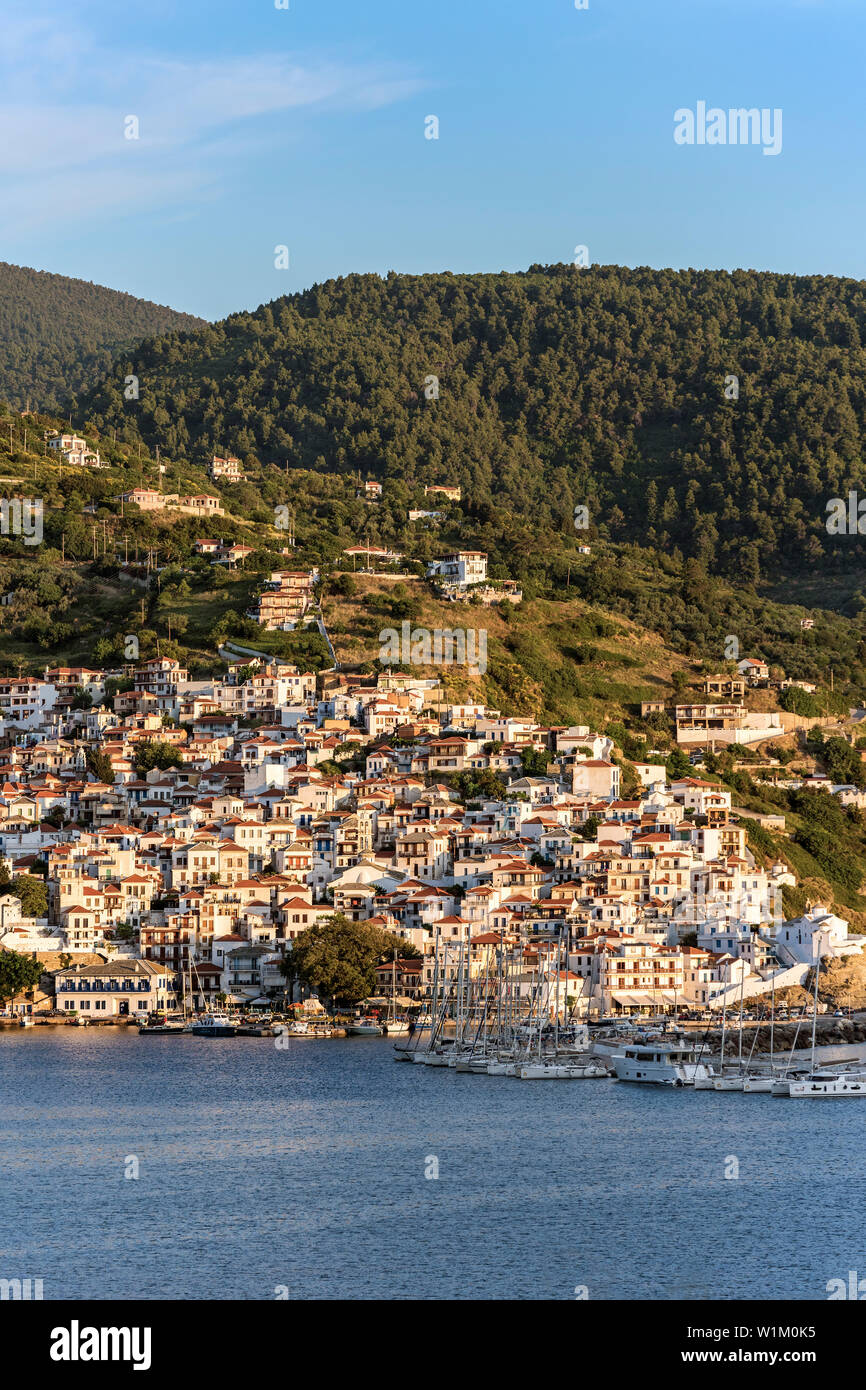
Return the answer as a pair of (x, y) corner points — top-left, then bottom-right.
(0, 1027), (866, 1300)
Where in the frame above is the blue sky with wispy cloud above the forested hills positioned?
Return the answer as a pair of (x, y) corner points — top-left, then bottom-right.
(0, 0), (866, 318)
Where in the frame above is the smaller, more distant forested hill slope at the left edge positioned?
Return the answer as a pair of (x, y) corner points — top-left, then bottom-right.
(0, 261), (203, 410)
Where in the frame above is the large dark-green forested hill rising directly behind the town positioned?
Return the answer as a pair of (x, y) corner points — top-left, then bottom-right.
(86, 265), (866, 586)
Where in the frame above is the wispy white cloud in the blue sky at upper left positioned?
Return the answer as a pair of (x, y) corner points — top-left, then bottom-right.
(0, 15), (423, 231)
